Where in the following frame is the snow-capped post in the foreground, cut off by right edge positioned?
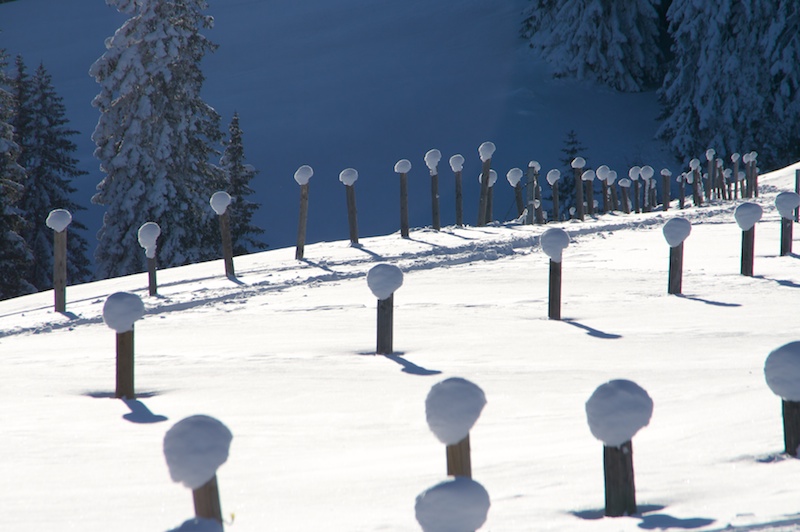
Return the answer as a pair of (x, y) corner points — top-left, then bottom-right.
(764, 342), (800, 458)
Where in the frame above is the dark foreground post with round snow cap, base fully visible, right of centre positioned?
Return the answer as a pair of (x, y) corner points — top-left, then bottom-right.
(586, 379), (653, 517)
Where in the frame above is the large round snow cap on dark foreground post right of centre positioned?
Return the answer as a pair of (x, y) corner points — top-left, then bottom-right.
(586, 379), (653, 447)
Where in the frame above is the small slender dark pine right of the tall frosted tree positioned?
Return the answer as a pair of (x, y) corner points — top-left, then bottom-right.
(220, 113), (267, 255)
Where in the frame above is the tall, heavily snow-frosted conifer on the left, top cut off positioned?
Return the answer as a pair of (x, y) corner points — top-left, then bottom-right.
(90, 0), (225, 278)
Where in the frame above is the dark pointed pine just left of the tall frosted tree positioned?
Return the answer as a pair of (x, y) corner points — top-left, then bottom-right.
(12, 56), (91, 290)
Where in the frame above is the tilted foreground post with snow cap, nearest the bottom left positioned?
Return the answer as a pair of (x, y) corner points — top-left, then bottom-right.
(164, 415), (233, 525)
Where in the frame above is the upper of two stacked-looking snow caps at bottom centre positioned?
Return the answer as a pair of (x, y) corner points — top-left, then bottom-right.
(425, 377), (486, 445)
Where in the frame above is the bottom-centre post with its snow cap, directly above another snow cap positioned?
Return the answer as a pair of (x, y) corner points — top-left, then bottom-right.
(425, 377), (486, 478)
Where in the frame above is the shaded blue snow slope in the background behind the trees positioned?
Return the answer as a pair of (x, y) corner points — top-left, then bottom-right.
(0, 0), (672, 262)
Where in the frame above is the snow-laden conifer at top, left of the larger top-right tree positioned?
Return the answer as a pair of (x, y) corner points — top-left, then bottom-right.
(523, 0), (664, 92)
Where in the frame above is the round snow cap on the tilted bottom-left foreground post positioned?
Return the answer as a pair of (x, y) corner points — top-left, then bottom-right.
(164, 415), (233, 490)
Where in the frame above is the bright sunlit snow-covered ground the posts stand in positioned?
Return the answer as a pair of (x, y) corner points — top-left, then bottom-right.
(0, 165), (800, 532)
